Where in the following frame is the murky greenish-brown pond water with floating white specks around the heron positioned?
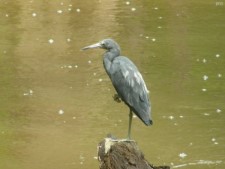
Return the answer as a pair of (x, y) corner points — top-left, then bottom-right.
(0, 0), (225, 169)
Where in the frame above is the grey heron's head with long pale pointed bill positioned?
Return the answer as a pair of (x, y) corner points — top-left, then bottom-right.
(81, 39), (120, 51)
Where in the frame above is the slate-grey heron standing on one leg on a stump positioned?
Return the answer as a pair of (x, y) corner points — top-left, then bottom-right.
(81, 39), (153, 140)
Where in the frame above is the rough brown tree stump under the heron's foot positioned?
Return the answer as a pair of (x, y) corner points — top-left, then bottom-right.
(98, 138), (170, 169)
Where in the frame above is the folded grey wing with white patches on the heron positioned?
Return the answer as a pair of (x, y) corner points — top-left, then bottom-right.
(110, 56), (151, 125)
